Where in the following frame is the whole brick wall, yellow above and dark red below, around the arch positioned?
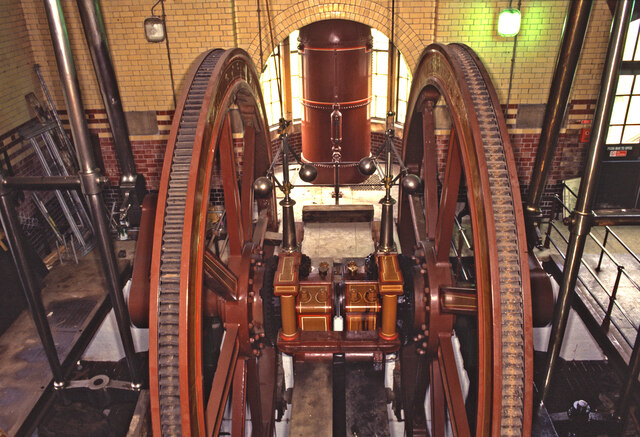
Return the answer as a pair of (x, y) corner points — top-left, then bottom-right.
(0, 0), (611, 245)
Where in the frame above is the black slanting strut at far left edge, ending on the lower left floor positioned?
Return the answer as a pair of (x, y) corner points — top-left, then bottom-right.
(0, 184), (65, 388)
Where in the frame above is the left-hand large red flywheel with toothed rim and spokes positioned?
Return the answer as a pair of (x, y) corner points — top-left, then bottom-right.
(149, 49), (276, 436)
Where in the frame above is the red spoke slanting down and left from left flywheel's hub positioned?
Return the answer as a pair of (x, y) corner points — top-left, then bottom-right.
(205, 324), (238, 436)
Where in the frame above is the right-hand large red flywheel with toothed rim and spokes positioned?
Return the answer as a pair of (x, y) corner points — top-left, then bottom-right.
(398, 44), (533, 436)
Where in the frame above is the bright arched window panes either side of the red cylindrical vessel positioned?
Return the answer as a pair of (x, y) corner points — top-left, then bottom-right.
(260, 28), (411, 125)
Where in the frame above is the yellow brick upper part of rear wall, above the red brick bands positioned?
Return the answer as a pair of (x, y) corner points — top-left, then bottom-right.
(6, 0), (611, 116)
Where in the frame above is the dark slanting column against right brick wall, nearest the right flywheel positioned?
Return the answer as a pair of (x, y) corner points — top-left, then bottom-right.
(524, 0), (593, 247)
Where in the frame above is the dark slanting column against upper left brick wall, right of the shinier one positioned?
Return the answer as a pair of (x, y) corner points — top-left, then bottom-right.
(77, 0), (136, 181)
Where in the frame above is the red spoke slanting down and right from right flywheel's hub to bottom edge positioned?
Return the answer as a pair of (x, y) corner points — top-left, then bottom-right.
(438, 334), (471, 437)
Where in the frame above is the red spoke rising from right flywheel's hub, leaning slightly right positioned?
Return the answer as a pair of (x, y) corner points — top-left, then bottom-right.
(436, 129), (462, 262)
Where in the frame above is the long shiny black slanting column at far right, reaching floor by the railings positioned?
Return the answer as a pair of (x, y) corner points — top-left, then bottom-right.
(541, 0), (640, 402)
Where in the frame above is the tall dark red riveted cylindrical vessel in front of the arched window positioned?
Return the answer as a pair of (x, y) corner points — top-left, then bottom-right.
(298, 20), (372, 183)
